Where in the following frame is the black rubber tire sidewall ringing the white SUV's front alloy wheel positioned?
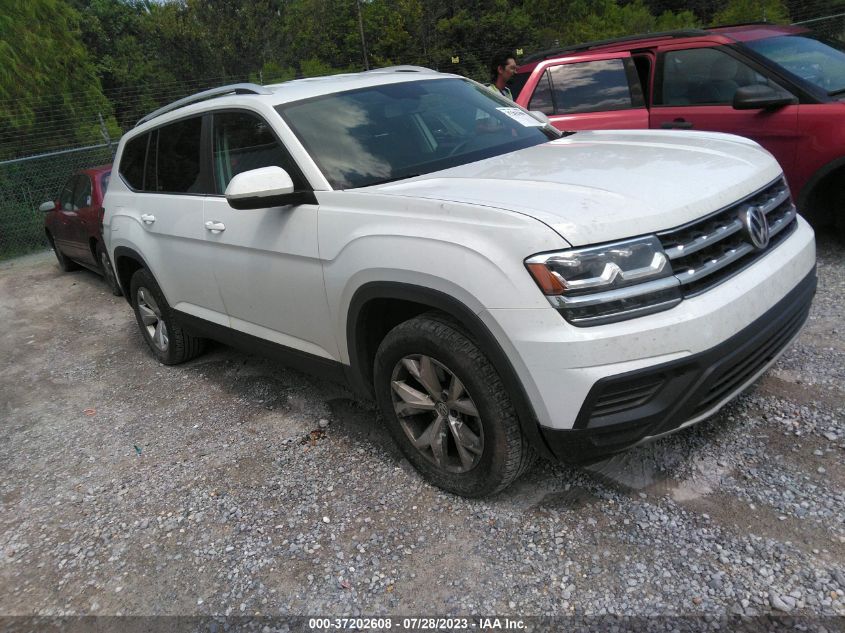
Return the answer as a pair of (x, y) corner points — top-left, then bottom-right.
(374, 324), (507, 497)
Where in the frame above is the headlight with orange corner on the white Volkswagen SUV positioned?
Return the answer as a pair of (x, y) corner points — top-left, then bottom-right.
(525, 237), (681, 326)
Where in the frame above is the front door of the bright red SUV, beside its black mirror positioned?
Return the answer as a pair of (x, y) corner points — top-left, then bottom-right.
(649, 42), (799, 179)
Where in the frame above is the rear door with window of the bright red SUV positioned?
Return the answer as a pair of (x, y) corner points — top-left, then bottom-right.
(516, 52), (648, 130)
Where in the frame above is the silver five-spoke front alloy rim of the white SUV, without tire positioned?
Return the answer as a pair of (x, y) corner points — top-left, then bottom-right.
(391, 354), (484, 473)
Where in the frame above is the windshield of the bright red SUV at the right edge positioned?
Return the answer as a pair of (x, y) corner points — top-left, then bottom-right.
(745, 35), (845, 95)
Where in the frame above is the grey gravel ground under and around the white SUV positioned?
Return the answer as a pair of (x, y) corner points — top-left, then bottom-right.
(0, 242), (845, 631)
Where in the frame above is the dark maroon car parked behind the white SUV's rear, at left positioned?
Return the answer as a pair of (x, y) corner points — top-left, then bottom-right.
(40, 165), (121, 295)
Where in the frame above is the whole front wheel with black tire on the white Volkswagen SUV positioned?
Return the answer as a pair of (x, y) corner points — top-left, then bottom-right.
(374, 313), (535, 497)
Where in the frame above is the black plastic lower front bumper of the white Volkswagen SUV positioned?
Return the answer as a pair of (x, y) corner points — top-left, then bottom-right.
(540, 268), (816, 463)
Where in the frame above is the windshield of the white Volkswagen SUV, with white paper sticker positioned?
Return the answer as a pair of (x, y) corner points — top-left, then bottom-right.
(276, 78), (559, 189)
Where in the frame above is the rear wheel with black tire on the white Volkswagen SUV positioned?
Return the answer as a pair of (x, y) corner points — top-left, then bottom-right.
(129, 268), (205, 365)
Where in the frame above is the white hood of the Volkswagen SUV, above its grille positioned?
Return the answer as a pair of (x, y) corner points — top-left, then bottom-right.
(367, 130), (781, 246)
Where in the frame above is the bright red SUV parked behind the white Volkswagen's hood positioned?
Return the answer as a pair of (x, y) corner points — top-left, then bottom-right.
(513, 24), (845, 236)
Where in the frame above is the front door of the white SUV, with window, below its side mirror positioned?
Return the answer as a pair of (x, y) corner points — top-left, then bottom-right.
(204, 110), (339, 360)
